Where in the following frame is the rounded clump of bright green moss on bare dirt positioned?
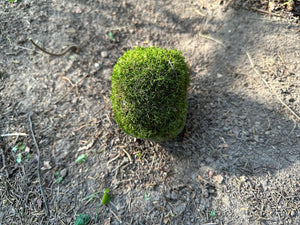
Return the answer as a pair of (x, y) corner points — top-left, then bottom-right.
(111, 47), (190, 141)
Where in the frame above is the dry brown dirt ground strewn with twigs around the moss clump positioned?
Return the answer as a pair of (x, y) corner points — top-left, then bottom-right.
(0, 0), (300, 225)
